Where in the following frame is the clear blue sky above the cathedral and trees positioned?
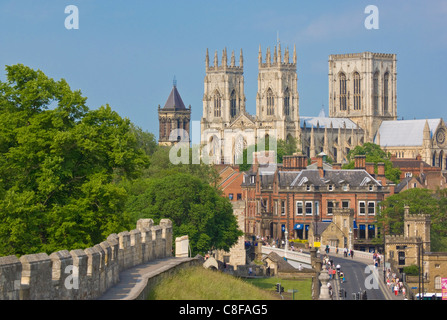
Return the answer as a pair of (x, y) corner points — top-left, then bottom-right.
(0, 0), (447, 137)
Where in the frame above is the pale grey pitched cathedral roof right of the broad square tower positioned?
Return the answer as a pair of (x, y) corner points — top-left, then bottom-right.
(374, 118), (441, 147)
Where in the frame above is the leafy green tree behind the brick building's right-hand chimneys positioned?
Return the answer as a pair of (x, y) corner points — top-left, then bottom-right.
(343, 142), (401, 184)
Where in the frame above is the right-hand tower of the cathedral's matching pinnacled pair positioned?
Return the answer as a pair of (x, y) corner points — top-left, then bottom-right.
(256, 42), (300, 140)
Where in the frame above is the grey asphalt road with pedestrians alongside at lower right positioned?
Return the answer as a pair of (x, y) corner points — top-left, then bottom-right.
(329, 255), (386, 300)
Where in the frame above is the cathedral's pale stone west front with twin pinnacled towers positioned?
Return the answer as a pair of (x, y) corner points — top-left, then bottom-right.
(201, 44), (300, 164)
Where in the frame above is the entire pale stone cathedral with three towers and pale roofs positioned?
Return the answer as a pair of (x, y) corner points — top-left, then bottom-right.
(159, 43), (447, 170)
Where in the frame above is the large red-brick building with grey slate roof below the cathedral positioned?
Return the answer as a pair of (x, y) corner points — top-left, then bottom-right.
(242, 155), (394, 251)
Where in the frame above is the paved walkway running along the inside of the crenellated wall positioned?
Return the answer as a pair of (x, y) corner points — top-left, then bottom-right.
(98, 257), (194, 300)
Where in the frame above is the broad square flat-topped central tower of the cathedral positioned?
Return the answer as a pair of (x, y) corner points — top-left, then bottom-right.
(329, 52), (397, 142)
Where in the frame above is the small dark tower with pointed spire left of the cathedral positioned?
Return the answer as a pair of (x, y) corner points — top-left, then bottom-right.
(158, 80), (191, 146)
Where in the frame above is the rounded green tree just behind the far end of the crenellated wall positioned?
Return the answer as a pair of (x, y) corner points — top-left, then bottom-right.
(126, 172), (242, 254)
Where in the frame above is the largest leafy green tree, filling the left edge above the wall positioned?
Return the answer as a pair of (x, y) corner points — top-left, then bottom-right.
(0, 64), (149, 255)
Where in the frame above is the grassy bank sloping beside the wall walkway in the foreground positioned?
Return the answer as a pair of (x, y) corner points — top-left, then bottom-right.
(148, 266), (311, 300)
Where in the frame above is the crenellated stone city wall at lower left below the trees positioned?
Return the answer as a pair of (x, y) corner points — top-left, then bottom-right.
(0, 219), (172, 300)
